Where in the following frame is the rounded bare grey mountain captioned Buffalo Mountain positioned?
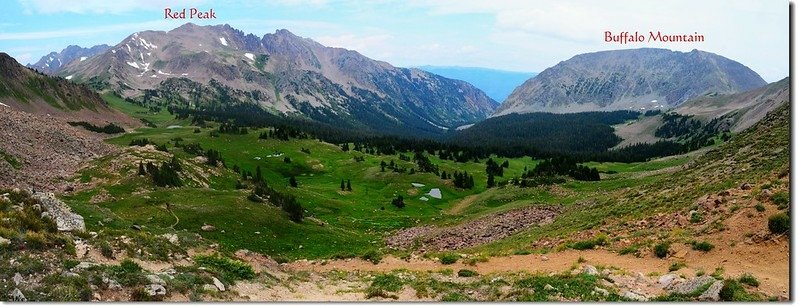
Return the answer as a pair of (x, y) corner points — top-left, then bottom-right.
(494, 48), (766, 115)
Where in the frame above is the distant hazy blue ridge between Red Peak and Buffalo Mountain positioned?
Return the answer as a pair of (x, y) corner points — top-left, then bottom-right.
(417, 65), (536, 102)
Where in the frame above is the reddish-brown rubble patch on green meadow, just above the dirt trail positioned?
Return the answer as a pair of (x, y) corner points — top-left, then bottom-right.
(386, 207), (558, 250)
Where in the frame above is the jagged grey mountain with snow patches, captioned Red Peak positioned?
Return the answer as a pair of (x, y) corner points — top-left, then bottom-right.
(59, 23), (496, 135)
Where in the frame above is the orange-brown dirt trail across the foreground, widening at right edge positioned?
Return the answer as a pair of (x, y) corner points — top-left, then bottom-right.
(286, 243), (790, 296)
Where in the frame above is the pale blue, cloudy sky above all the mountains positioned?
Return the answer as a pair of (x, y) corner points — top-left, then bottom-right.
(0, 0), (789, 82)
